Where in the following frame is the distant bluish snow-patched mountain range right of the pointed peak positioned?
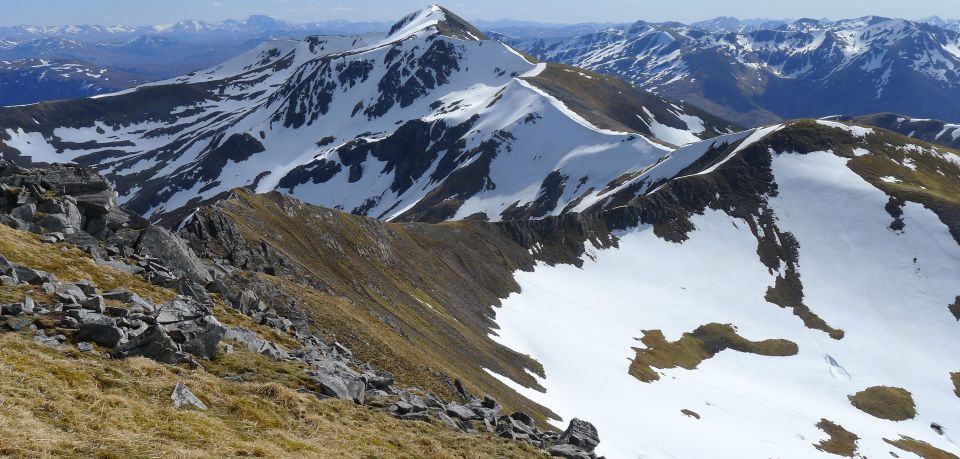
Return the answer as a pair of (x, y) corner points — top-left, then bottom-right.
(510, 16), (960, 125)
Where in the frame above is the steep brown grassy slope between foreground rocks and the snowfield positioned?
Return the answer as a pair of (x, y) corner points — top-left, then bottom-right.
(189, 191), (552, 422)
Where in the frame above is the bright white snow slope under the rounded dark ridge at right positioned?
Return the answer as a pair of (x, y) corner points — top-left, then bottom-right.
(494, 121), (960, 458)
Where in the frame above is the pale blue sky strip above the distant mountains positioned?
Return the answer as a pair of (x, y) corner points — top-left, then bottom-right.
(0, 0), (960, 25)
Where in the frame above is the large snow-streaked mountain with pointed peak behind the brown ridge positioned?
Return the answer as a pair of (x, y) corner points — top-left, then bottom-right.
(0, 6), (732, 221)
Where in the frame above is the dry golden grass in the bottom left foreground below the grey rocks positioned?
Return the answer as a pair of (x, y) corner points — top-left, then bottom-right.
(0, 334), (543, 458)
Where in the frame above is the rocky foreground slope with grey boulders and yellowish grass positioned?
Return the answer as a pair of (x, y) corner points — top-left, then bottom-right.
(0, 162), (599, 457)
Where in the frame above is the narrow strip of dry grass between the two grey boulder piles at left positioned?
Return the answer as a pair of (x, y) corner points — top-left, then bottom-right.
(0, 225), (176, 303)
